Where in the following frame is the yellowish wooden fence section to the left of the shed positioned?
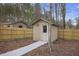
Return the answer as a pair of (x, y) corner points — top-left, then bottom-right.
(0, 28), (32, 41)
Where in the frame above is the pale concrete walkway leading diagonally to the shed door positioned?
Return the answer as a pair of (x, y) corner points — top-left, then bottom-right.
(0, 41), (47, 56)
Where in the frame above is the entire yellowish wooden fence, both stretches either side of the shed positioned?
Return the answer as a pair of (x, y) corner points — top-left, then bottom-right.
(0, 28), (79, 41)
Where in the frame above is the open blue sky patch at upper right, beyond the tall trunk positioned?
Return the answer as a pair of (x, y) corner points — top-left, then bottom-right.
(66, 3), (79, 20)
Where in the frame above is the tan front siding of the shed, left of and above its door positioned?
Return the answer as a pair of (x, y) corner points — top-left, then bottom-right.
(33, 21), (48, 40)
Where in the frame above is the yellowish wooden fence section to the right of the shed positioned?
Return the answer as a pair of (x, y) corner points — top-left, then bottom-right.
(58, 29), (79, 40)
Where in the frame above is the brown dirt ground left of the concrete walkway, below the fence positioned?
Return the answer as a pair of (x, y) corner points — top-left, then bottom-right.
(0, 39), (35, 54)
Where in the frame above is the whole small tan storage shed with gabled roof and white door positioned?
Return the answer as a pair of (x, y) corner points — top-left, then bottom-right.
(32, 18), (58, 41)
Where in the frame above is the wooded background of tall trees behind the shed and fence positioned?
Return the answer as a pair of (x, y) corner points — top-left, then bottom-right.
(0, 3), (79, 29)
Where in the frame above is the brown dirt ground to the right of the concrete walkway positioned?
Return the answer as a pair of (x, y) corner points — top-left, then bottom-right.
(24, 39), (79, 56)
